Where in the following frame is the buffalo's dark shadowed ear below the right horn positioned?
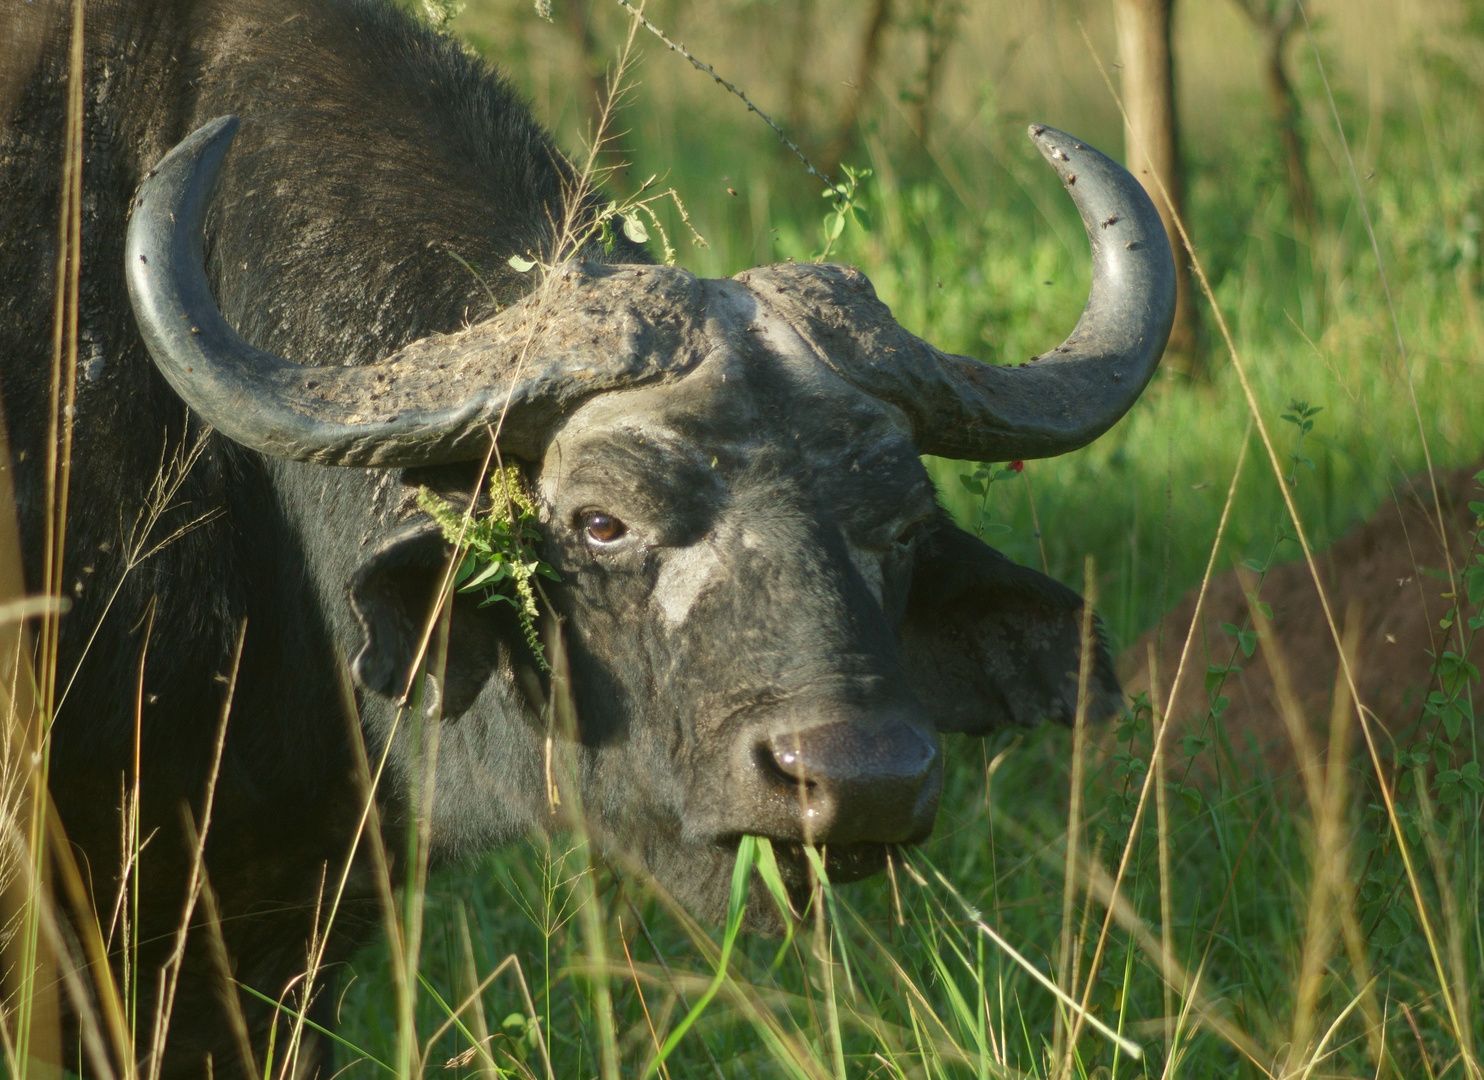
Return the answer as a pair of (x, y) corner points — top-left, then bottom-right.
(898, 513), (1122, 734)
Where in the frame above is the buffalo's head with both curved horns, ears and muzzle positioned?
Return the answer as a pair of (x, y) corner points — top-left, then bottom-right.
(126, 117), (1174, 915)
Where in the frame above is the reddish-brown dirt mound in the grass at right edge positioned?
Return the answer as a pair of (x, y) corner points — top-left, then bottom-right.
(1119, 466), (1484, 764)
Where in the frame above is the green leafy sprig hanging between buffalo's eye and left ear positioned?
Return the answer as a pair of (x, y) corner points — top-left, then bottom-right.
(417, 469), (561, 671)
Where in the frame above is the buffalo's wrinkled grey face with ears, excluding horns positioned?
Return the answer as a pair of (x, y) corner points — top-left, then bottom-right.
(344, 269), (1116, 918)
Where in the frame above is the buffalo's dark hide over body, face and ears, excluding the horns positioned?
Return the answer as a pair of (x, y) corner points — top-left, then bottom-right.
(0, 0), (1117, 1076)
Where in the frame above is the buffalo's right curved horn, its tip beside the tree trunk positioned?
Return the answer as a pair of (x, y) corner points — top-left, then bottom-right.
(739, 125), (1175, 461)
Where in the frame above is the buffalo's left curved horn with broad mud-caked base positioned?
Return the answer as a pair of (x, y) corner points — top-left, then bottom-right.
(125, 116), (709, 466)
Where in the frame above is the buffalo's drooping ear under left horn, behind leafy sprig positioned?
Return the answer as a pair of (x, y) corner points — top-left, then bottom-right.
(350, 524), (531, 720)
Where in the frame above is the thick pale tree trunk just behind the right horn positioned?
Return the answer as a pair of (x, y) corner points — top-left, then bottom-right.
(1113, 0), (1204, 375)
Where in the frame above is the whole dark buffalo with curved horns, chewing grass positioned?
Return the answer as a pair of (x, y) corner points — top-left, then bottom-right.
(0, 0), (1174, 1074)
